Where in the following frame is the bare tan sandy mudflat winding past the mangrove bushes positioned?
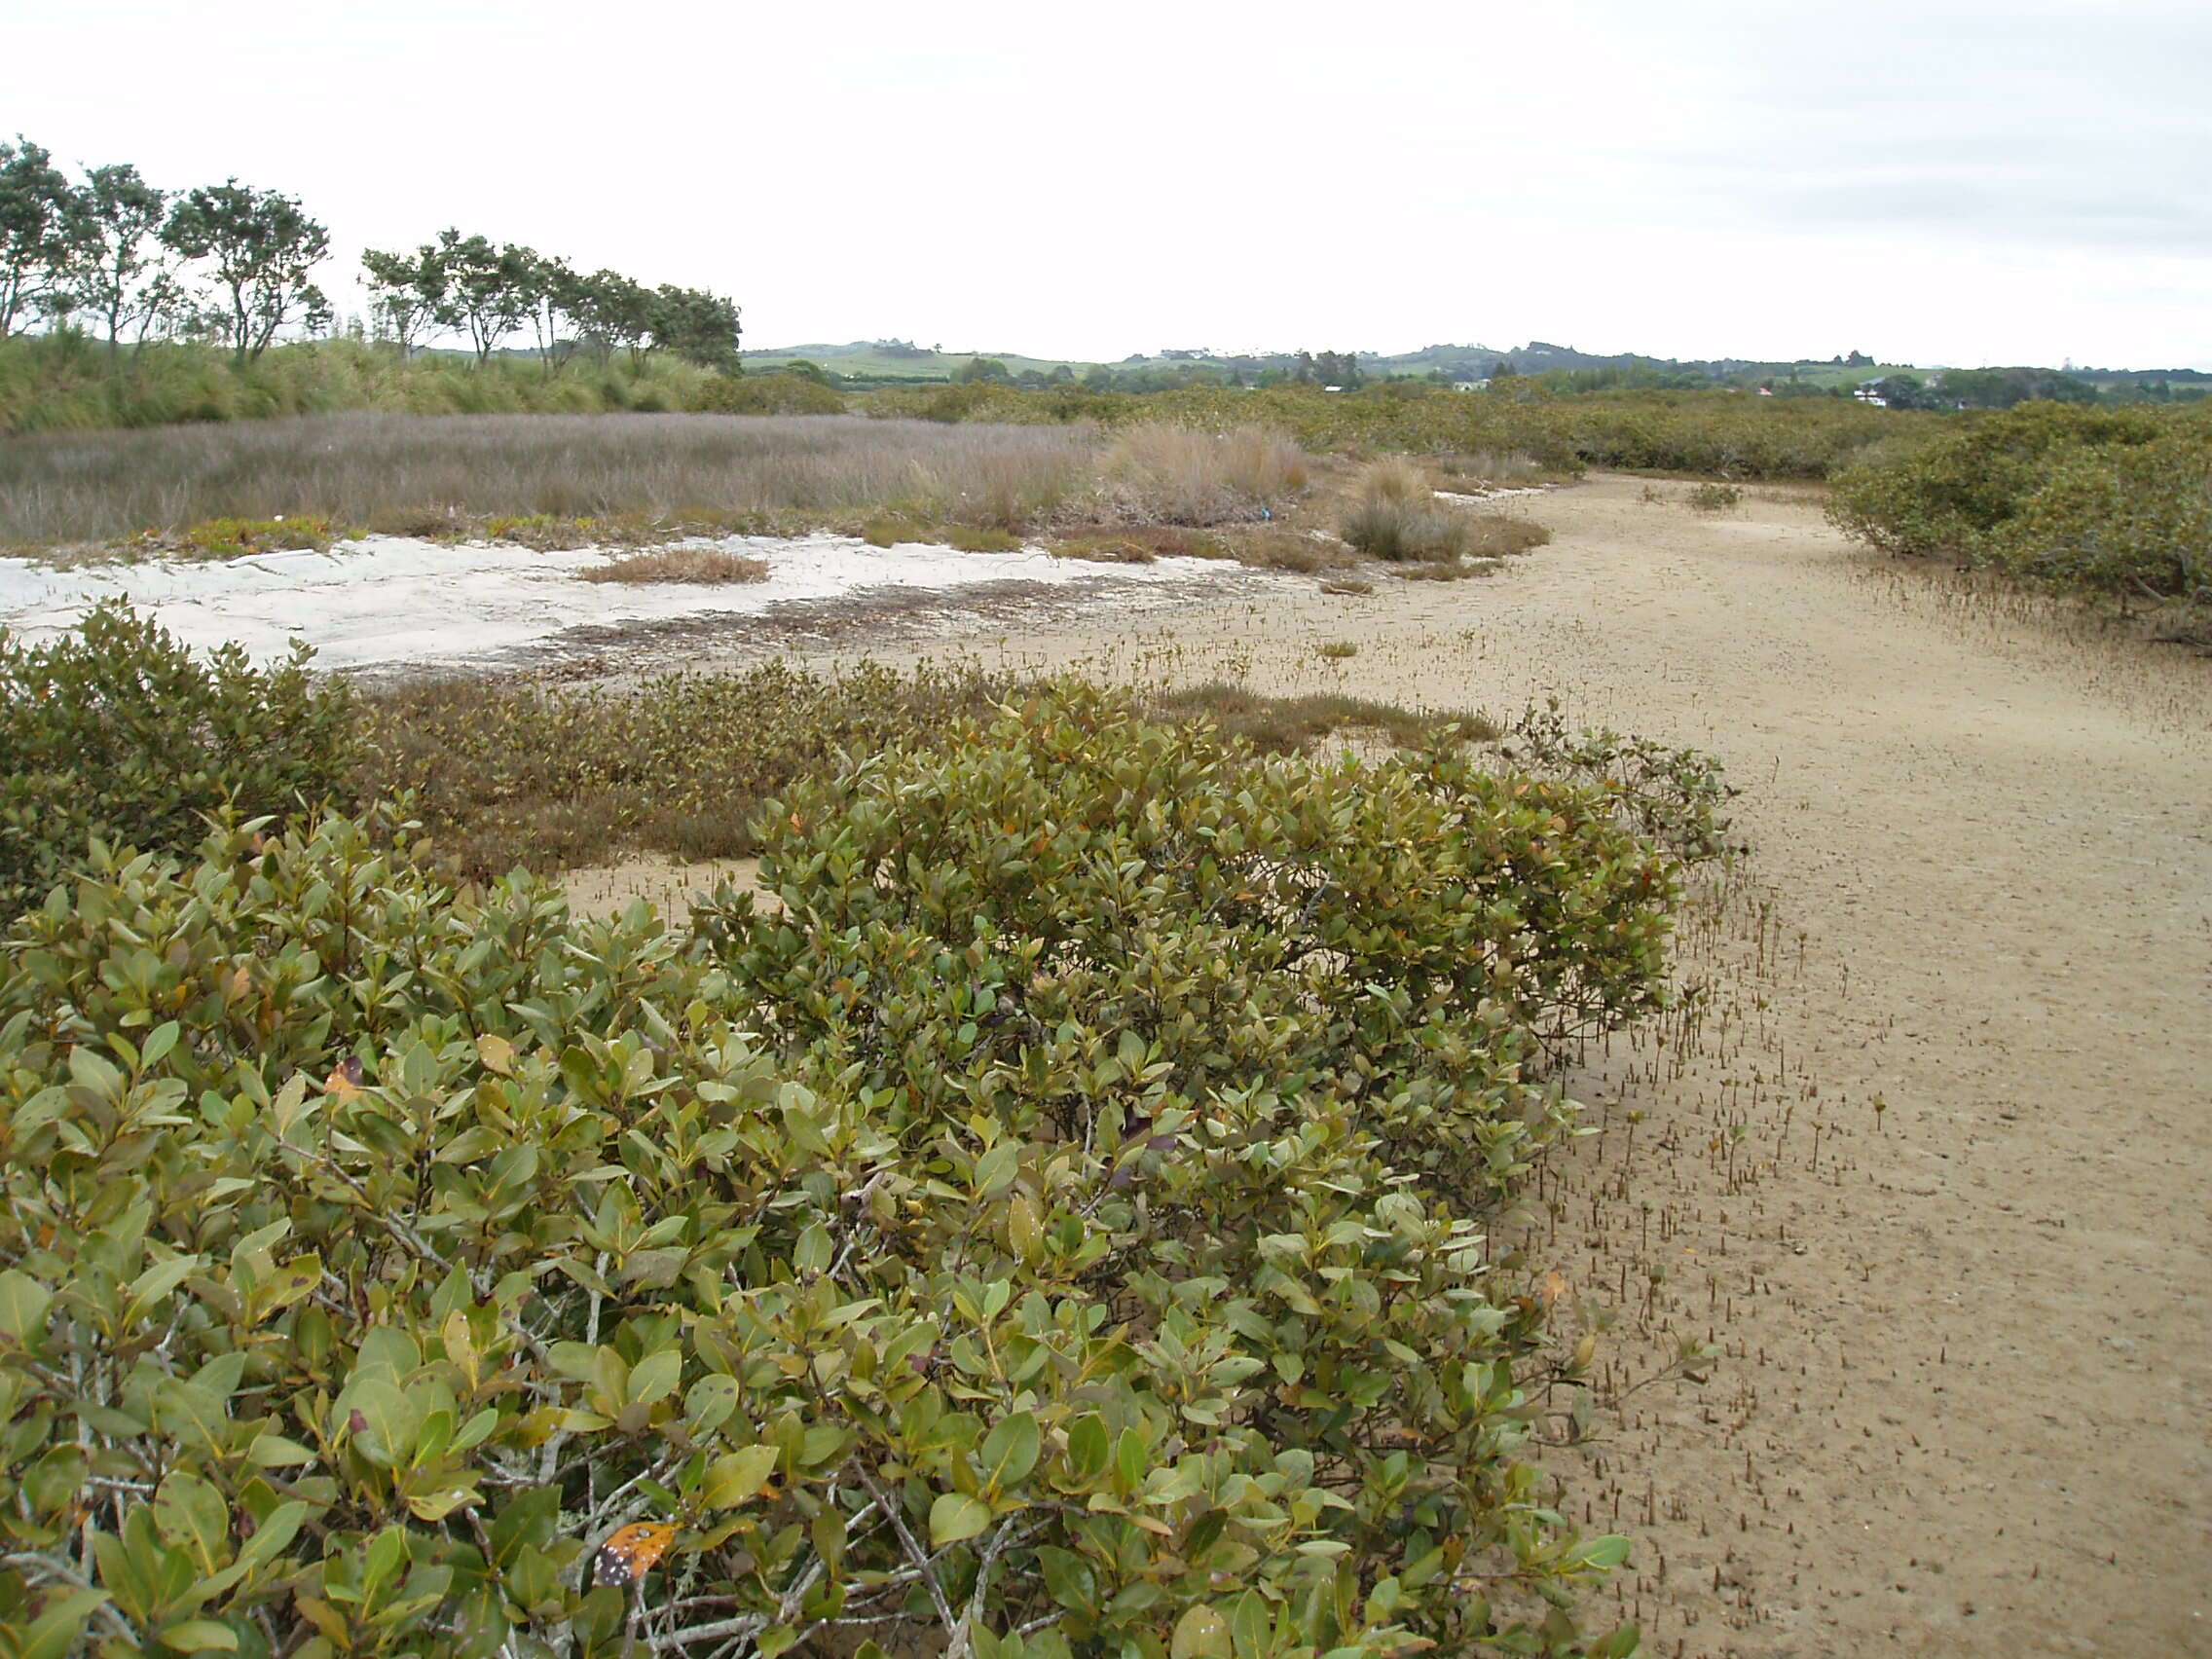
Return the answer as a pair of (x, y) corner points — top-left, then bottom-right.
(703, 478), (2212, 1654)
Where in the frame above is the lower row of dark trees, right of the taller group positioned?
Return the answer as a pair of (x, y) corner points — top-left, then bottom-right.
(360, 230), (743, 374)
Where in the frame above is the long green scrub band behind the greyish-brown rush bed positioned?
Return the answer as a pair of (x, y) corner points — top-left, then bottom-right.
(0, 334), (1920, 491)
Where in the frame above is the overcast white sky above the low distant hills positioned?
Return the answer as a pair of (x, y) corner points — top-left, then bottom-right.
(0, 0), (2212, 367)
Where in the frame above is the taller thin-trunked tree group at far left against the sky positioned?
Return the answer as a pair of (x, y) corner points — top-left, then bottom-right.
(0, 135), (330, 363)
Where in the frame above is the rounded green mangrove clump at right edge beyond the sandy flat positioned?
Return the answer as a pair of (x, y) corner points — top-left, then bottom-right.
(1829, 403), (2212, 624)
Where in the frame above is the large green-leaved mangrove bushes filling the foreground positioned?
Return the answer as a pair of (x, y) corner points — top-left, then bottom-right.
(0, 610), (1716, 1659)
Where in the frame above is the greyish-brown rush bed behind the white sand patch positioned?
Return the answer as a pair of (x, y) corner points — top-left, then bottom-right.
(0, 414), (1309, 579)
